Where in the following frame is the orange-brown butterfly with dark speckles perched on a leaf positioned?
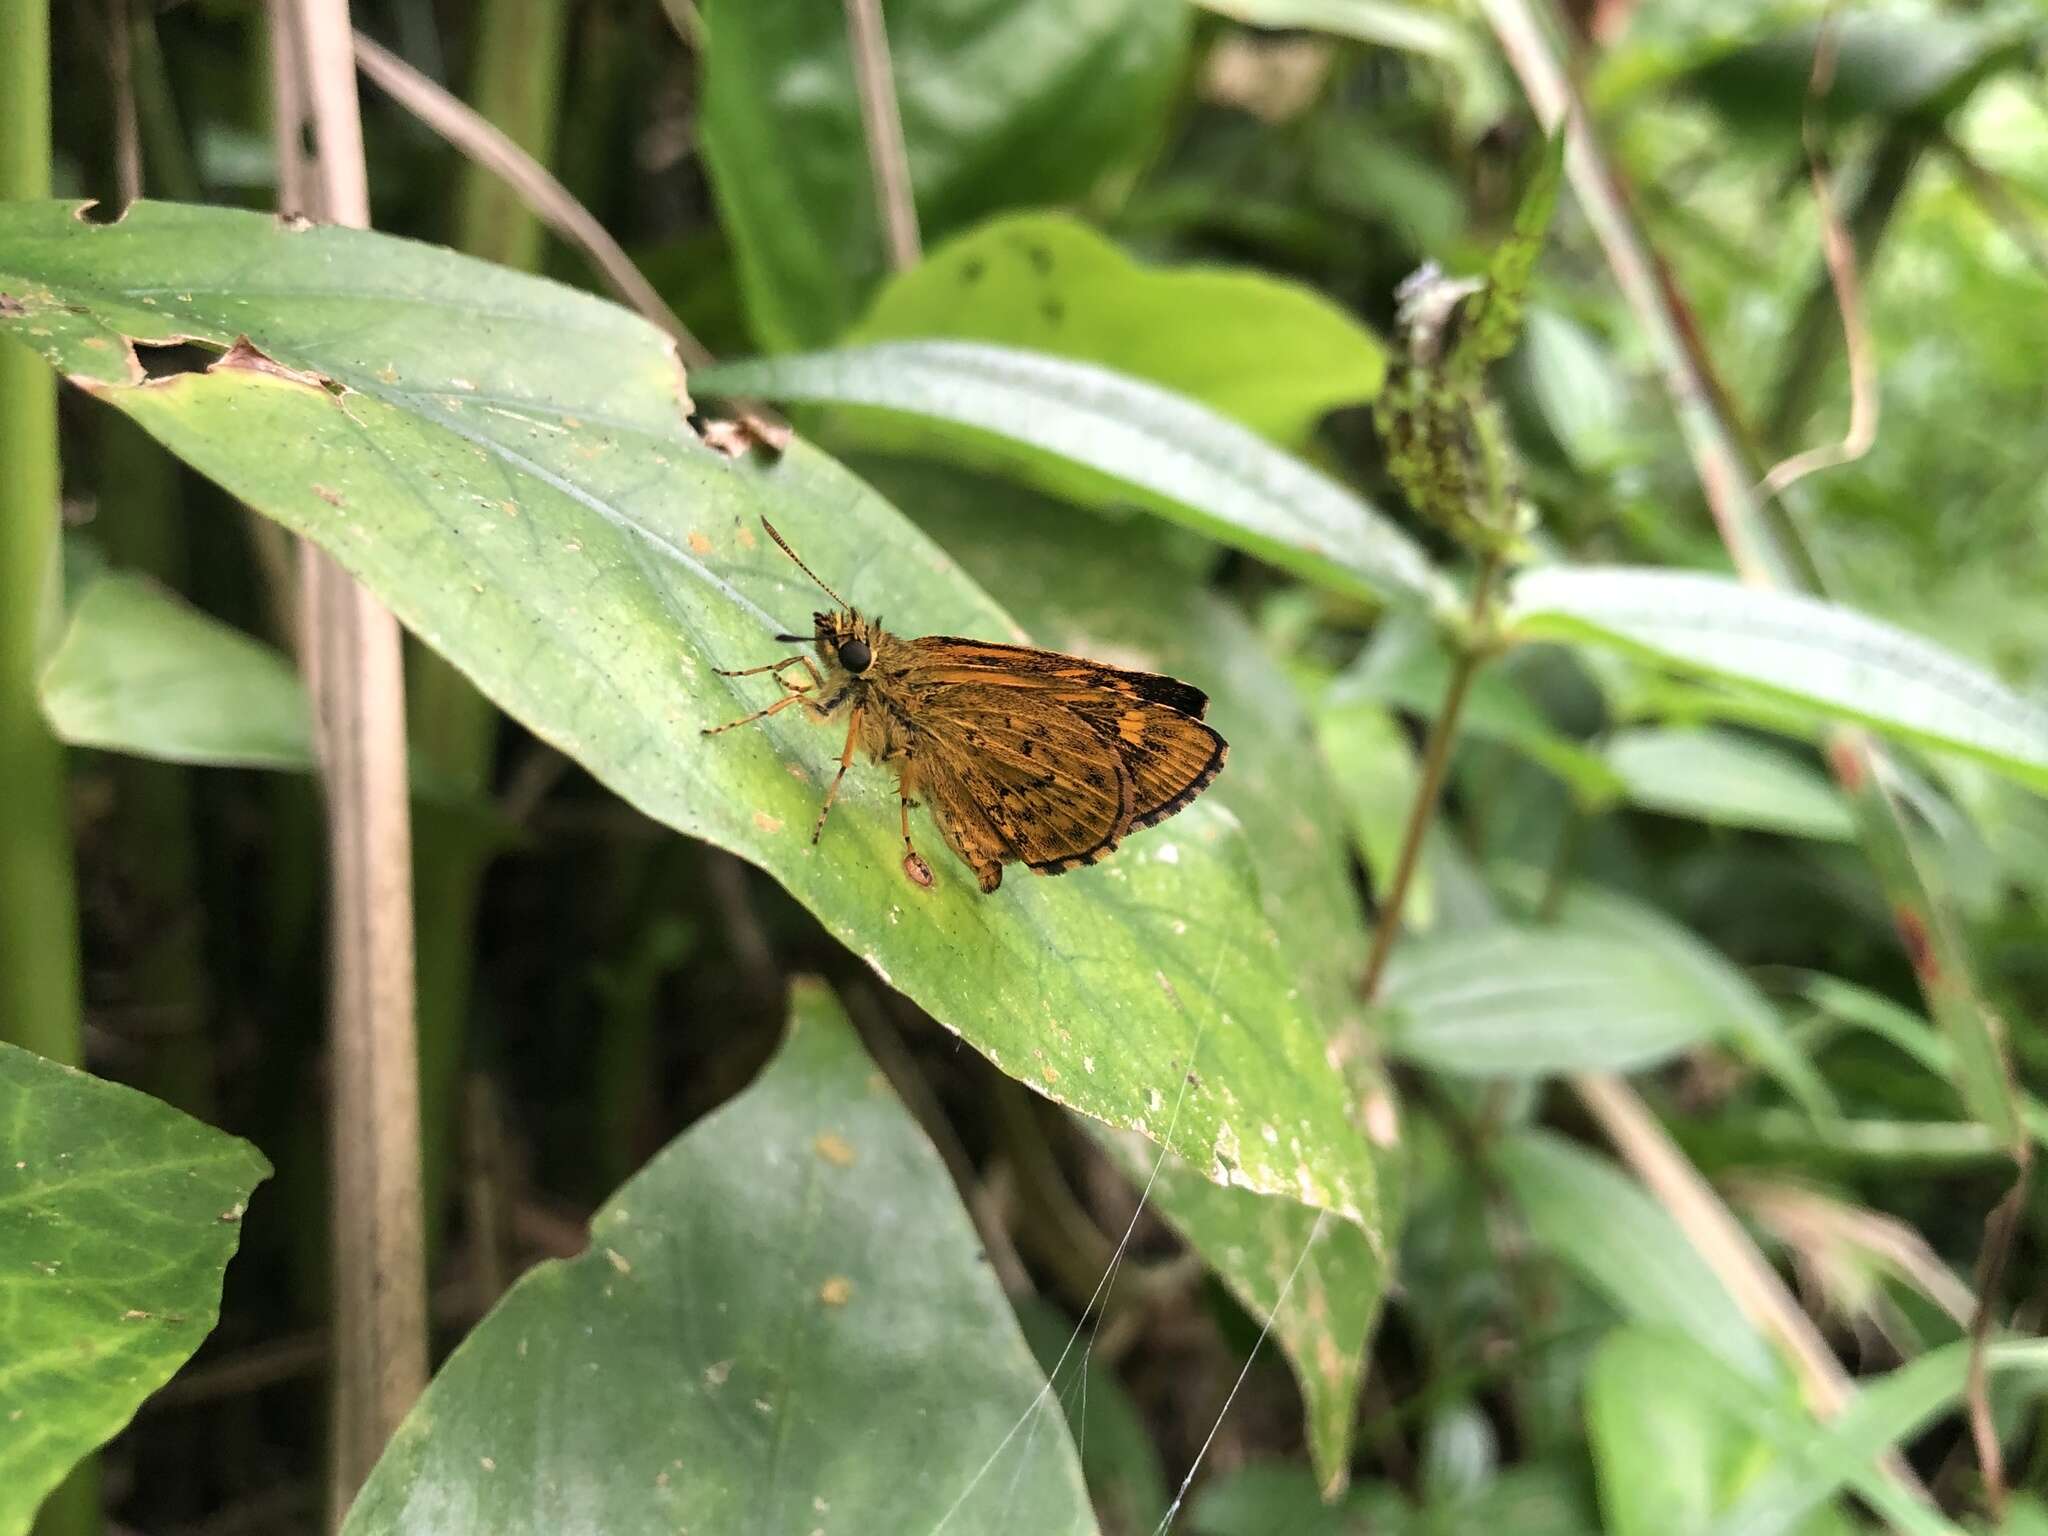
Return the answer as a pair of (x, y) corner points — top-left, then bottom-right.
(705, 518), (1229, 891)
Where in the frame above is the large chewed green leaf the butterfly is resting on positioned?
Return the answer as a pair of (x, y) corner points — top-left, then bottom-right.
(0, 203), (1380, 1235)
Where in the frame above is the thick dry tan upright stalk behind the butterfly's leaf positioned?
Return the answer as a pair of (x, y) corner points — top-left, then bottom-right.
(272, 0), (426, 1522)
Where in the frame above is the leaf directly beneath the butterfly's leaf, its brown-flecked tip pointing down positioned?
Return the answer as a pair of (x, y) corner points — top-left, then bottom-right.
(862, 461), (1399, 1487)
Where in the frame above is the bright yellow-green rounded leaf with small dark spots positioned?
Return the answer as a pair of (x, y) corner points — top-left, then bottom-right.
(846, 213), (1386, 449)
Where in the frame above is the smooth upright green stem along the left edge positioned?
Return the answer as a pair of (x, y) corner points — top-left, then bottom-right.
(0, 18), (100, 1536)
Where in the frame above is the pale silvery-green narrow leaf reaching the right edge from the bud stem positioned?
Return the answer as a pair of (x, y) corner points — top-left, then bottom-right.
(1507, 565), (2048, 788)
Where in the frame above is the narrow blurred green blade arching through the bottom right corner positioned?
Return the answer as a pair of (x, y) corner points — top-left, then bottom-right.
(1712, 1339), (2048, 1536)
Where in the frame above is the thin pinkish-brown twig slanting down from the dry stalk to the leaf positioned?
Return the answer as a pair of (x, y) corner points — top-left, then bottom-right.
(354, 33), (713, 369)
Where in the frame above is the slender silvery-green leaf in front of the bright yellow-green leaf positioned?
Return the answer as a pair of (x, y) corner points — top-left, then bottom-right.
(698, 342), (1440, 602)
